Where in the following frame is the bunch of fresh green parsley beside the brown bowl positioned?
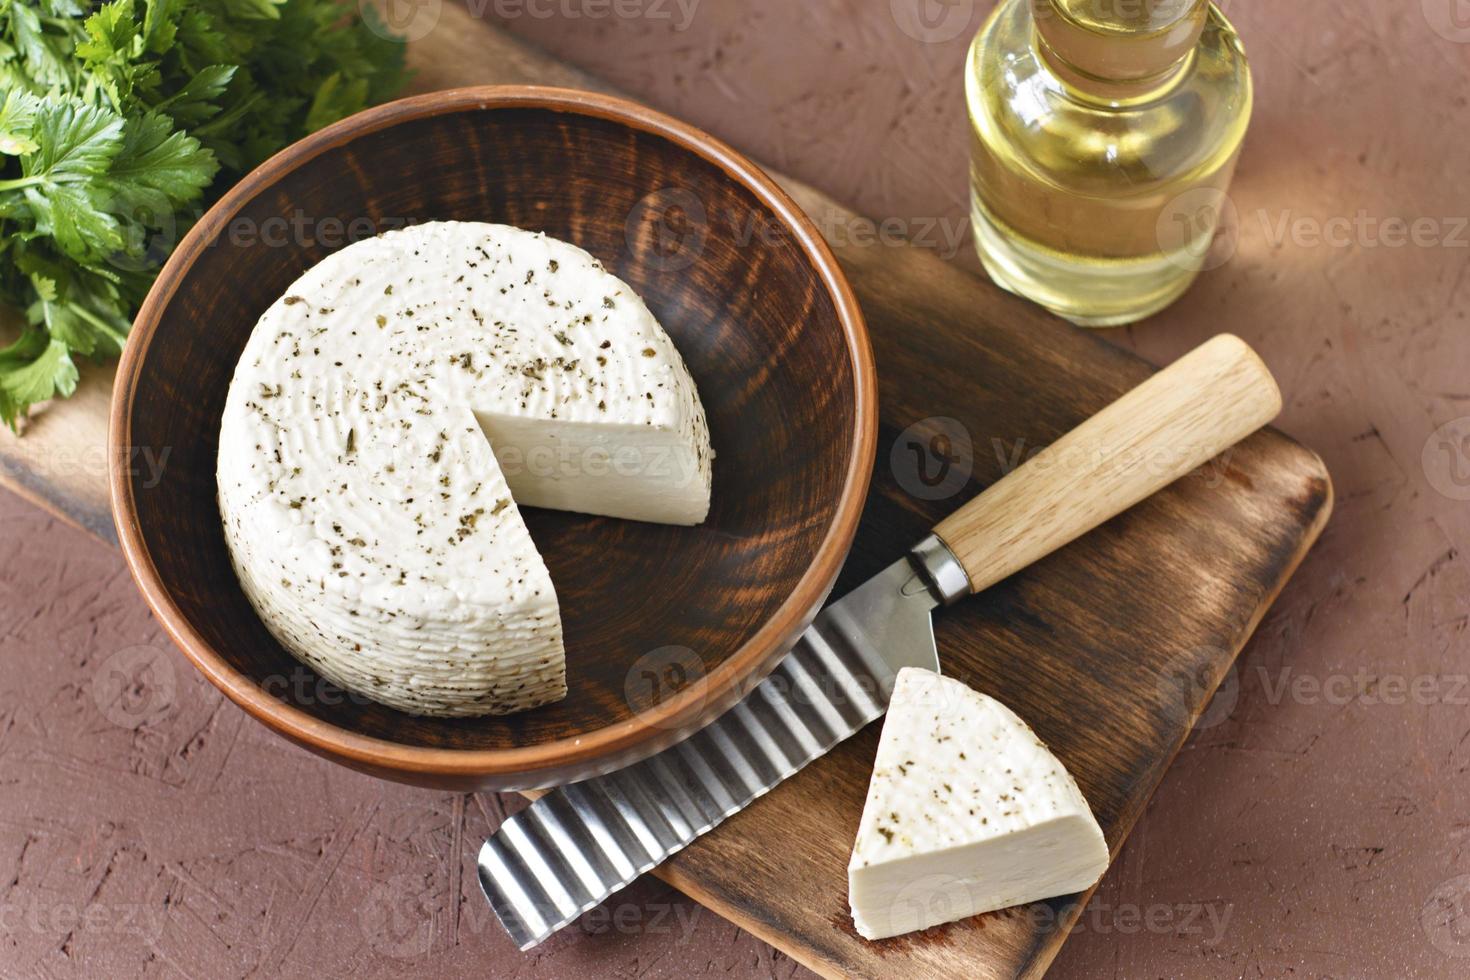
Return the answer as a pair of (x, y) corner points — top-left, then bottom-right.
(0, 0), (404, 428)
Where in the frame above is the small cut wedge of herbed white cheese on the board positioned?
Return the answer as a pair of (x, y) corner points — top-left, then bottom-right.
(847, 667), (1108, 939)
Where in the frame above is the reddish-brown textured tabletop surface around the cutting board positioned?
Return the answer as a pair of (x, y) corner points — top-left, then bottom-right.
(0, 0), (1470, 977)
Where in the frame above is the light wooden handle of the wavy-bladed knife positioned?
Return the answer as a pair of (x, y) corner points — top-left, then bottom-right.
(935, 334), (1282, 592)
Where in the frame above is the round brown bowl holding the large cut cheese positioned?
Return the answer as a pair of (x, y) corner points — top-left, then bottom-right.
(110, 87), (876, 789)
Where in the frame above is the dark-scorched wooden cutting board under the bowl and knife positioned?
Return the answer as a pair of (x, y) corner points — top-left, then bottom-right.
(0, 13), (1332, 980)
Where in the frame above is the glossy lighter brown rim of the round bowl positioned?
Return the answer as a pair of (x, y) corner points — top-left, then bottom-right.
(107, 85), (878, 785)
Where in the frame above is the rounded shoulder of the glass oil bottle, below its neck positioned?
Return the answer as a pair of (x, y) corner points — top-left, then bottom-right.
(966, 0), (1252, 192)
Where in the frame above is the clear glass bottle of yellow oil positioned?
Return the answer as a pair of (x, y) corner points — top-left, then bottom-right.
(966, 0), (1251, 326)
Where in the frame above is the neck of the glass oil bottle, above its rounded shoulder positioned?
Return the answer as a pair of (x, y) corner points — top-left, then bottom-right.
(1029, 0), (1210, 103)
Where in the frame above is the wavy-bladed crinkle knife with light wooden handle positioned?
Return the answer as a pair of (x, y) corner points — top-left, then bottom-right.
(479, 335), (1282, 949)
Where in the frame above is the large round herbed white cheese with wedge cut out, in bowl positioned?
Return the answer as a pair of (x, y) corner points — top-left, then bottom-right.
(218, 222), (711, 717)
